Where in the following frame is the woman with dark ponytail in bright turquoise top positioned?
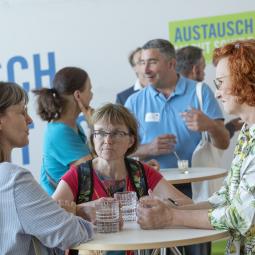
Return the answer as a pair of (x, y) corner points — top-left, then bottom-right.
(34, 67), (93, 195)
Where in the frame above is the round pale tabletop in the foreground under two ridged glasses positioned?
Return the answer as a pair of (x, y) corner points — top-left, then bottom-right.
(75, 222), (229, 254)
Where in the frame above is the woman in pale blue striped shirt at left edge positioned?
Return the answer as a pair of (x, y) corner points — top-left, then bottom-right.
(0, 82), (93, 255)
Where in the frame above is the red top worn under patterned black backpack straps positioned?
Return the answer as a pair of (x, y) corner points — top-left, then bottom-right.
(62, 163), (163, 201)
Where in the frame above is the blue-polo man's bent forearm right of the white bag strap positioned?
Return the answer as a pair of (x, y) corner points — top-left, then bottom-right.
(208, 120), (230, 150)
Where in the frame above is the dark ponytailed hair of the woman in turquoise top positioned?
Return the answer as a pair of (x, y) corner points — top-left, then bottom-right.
(33, 67), (88, 122)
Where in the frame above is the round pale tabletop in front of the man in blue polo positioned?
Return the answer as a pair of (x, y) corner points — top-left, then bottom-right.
(160, 167), (228, 184)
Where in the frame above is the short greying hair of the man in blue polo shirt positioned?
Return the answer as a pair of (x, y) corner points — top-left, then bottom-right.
(142, 39), (176, 59)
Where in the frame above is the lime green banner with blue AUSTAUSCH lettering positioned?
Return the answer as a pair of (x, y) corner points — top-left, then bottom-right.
(169, 11), (255, 63)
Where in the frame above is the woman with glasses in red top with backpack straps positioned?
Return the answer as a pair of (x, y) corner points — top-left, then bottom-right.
(53, 101), (192, 217)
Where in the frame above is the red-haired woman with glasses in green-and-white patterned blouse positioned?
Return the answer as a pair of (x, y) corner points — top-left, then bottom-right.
(138, 39), (255, 255)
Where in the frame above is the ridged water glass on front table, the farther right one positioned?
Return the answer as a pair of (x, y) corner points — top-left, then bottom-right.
(114, 191), (137, 222)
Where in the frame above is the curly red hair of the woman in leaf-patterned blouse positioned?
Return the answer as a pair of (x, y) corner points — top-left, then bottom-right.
(213, 39), (255, 106)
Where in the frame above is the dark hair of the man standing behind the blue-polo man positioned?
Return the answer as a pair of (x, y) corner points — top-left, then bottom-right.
(176, 46), (203, 76)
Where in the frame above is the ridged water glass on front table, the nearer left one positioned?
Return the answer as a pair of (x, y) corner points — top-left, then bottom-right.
(95, 198), (120, 233)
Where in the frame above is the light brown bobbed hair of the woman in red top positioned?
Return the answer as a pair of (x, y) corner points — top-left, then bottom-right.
(90, 103), (139, 156)
